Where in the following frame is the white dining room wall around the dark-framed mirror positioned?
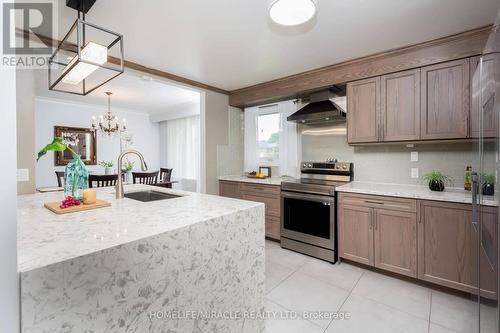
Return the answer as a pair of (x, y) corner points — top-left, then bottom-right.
(35, 98), (160, 187)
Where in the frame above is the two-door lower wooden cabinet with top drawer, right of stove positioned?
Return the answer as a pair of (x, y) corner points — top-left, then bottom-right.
(338, 193), (417, 277)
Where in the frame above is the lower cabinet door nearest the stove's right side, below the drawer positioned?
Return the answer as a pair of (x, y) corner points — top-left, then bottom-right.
(338, 205), (373, 265)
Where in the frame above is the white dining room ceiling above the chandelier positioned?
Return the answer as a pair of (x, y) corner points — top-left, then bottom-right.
(36, 71), (200, 115)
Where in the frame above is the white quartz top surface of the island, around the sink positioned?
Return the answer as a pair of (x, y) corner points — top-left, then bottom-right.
(17, 185), (262, 272)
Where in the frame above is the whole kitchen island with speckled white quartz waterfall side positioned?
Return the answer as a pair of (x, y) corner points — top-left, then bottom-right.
(18, 185), (265, 333)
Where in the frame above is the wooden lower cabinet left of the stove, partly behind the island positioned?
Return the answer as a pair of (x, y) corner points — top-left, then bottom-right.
(219, 180), (281, 240)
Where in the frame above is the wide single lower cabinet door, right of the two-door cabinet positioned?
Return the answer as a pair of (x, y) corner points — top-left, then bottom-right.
(418, 201), (477, 293)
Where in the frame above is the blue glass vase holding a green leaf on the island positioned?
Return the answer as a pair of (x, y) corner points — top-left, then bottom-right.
(64, 155), (89, 200)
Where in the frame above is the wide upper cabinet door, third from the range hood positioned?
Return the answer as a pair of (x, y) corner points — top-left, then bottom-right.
(420, 59), (470, 140)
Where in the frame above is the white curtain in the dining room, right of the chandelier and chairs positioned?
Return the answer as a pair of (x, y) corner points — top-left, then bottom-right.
(160, 116), (200, 191)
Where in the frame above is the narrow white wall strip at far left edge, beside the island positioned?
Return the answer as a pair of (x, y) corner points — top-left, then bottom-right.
(0, 63), (19, 333)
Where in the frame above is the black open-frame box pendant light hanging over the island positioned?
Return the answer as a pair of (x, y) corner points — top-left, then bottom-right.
(48, 0), (124, 96)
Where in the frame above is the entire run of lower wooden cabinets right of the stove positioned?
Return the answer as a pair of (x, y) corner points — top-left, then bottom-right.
(337, 193), (498, 299)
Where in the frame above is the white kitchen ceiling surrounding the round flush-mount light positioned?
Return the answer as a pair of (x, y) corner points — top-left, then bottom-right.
(53, 0), (500, 90)
